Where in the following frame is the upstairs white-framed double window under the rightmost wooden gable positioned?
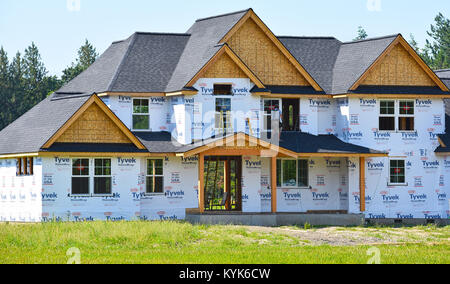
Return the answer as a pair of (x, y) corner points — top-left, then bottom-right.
(379, 100), (414, 131)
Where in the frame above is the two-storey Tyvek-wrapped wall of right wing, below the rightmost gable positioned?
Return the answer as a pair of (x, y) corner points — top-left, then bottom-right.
(338, 98), (450, 219)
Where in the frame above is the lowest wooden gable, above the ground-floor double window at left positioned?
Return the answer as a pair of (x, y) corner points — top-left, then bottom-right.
(42, 95), (146, 150)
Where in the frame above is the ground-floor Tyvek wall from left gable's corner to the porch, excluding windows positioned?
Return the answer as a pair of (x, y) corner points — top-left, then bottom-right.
(42, 157), (198, 222)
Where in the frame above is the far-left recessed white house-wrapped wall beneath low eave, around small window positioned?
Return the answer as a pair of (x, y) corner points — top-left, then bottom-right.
(0, 158), (42, 222)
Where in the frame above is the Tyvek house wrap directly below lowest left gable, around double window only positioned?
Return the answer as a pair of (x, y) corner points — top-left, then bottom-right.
(42, 157), (141, 222)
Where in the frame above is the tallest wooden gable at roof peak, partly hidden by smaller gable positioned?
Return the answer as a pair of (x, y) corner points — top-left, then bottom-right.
(219, 10), (322, 91)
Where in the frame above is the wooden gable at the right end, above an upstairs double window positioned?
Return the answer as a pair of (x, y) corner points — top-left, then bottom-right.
(350, 35), (449, 92)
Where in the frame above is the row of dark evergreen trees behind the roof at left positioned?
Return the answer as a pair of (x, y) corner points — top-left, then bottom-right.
(0, 40), (98, 130)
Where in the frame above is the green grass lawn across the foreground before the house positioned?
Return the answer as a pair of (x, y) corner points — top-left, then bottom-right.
(0, 222), (450, 264)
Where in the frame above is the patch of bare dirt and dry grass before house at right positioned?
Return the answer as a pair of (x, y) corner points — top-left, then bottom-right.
(244, 227), (450, 246)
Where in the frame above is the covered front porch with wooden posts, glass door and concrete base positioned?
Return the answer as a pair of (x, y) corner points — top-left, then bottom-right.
(178, 133), (386, 216)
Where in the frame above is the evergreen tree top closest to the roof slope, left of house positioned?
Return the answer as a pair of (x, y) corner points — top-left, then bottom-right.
(61, 39), (98, 83)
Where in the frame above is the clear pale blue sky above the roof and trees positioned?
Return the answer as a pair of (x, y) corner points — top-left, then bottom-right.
(0, 0), (450, 75)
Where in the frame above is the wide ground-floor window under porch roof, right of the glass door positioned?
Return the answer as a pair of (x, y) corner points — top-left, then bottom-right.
(277, 160), (309, 187)
